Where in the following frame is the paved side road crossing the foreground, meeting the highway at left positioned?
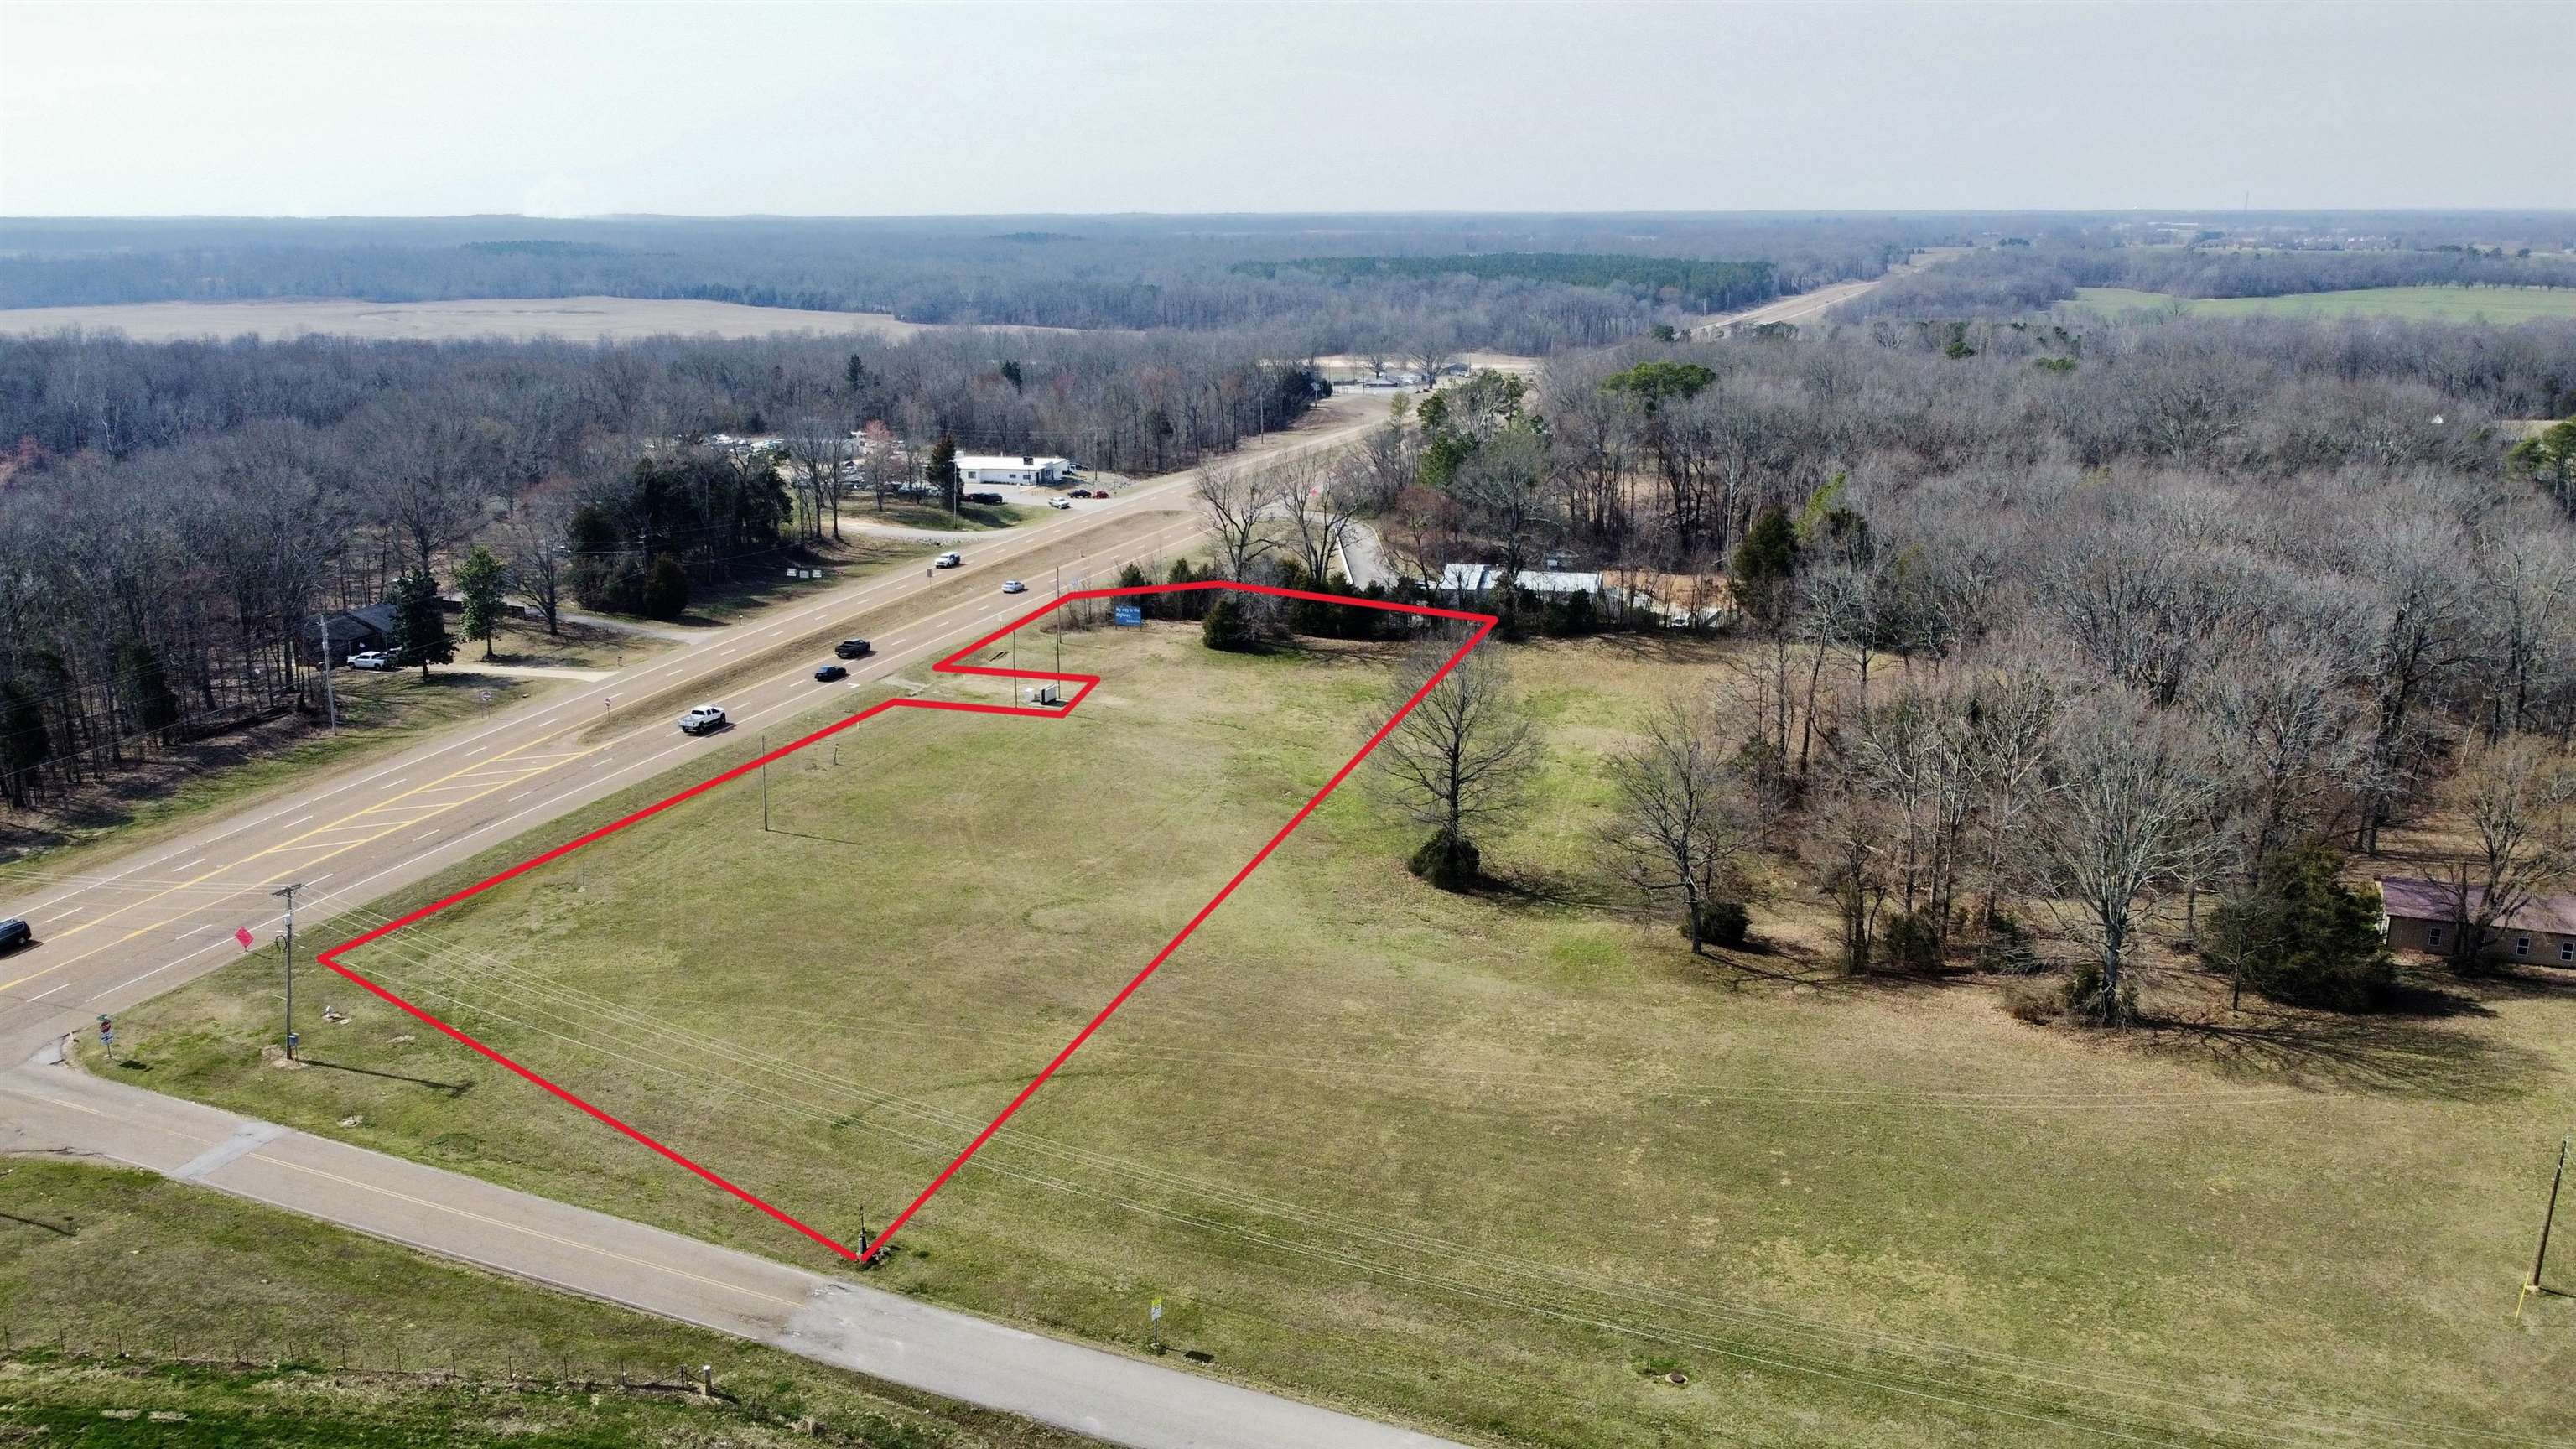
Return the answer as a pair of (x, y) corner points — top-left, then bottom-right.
(0, 1041), (1458, 1449)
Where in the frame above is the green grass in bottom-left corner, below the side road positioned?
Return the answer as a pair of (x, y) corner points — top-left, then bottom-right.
(0, 1158), (1089, 1449)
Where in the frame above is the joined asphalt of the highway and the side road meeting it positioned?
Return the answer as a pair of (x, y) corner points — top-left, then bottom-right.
(0, 387), (1473, 1449)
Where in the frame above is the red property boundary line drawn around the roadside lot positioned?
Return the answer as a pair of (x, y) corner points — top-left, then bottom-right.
(314, 580), (1497, 1258)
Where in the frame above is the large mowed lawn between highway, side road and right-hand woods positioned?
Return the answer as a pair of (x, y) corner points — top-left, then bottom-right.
(118, 626), (2576, 1446)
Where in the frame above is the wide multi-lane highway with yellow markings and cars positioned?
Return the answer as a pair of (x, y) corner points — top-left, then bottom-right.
(0, 389), (1379, 1060)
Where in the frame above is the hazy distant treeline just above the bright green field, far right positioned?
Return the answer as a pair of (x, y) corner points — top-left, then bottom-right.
(1839, 245), (2576, 317)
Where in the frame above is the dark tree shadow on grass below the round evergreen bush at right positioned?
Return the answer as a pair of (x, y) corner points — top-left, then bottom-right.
(2136, 1010), (2553, 1101)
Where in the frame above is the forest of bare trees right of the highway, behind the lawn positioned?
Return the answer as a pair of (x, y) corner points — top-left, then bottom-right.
(1298, 304), (2576, 1021)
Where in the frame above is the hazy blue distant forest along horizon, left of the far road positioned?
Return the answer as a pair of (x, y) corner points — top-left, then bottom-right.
(0, 216), (1966, 353)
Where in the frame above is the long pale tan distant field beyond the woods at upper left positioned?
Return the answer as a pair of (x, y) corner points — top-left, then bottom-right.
(0, 297), (1046, 343)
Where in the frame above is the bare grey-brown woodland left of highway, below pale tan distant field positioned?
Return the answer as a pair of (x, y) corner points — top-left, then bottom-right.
(0, 333), (1319, 802)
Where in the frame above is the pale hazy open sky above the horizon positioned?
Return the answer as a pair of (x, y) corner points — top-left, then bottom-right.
(0, 0), (2576, 216)
